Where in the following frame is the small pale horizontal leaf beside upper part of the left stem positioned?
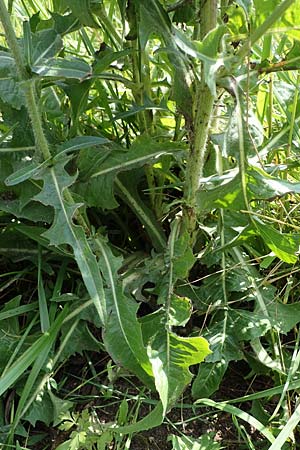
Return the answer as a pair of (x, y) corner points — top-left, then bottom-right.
(31, 57), (91, 80)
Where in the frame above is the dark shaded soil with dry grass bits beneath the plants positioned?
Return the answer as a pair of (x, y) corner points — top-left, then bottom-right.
(23, 361), (278, 450)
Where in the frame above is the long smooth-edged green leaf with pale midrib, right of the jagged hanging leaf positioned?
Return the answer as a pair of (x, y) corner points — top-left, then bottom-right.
(96, 238), (153, 386)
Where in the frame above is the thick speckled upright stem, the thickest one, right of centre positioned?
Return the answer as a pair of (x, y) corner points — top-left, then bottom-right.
(183, 0), (217, 239)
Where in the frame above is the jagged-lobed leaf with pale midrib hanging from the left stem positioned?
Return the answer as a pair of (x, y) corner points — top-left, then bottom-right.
(34, 157), (106, 324)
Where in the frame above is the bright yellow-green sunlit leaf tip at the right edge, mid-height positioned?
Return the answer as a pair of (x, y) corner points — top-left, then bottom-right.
(253, 217), (299, 264)
